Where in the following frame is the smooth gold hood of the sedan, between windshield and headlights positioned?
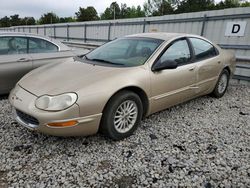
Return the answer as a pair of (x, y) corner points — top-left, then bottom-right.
(18, 58), (136, 96)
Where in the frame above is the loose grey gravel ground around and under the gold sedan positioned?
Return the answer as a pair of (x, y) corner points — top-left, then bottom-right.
(0, 84), (250, 188)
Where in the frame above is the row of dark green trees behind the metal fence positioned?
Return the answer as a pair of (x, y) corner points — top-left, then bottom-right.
(0, 0), (250, 27)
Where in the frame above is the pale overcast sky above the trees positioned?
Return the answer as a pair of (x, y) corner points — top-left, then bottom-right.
(0, 0), (145, 19)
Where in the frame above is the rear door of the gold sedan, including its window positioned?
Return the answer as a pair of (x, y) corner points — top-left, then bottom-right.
(189, 37), (223, 94)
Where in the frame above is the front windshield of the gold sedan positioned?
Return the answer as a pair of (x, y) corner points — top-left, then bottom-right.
(85, 37), (163, 67)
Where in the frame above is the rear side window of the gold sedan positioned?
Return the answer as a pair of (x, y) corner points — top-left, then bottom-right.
(190, 38), (217, 60)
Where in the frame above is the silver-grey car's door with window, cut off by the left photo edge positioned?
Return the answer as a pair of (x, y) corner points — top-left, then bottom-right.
(0, 36), (32, 94)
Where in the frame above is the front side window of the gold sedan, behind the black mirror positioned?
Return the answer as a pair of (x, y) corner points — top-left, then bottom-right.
(159, 39), (191, 66)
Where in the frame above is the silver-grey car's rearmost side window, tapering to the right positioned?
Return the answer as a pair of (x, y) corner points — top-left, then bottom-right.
(29, 38), (58, 53)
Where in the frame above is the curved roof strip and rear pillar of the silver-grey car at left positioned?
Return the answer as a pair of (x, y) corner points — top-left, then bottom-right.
(0, 32), (70, 51)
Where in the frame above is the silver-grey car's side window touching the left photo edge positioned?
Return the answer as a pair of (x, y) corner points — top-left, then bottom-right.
(0, 36), (27, 55)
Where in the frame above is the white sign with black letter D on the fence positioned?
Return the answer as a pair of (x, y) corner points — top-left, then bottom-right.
(225, 21), (247, 37)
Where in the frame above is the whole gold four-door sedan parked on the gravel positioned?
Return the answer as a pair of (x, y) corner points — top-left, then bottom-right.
(9, 33), (235, 140)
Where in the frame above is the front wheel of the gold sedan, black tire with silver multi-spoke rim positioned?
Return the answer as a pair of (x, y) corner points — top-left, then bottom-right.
(100, 90), (143, 140)
